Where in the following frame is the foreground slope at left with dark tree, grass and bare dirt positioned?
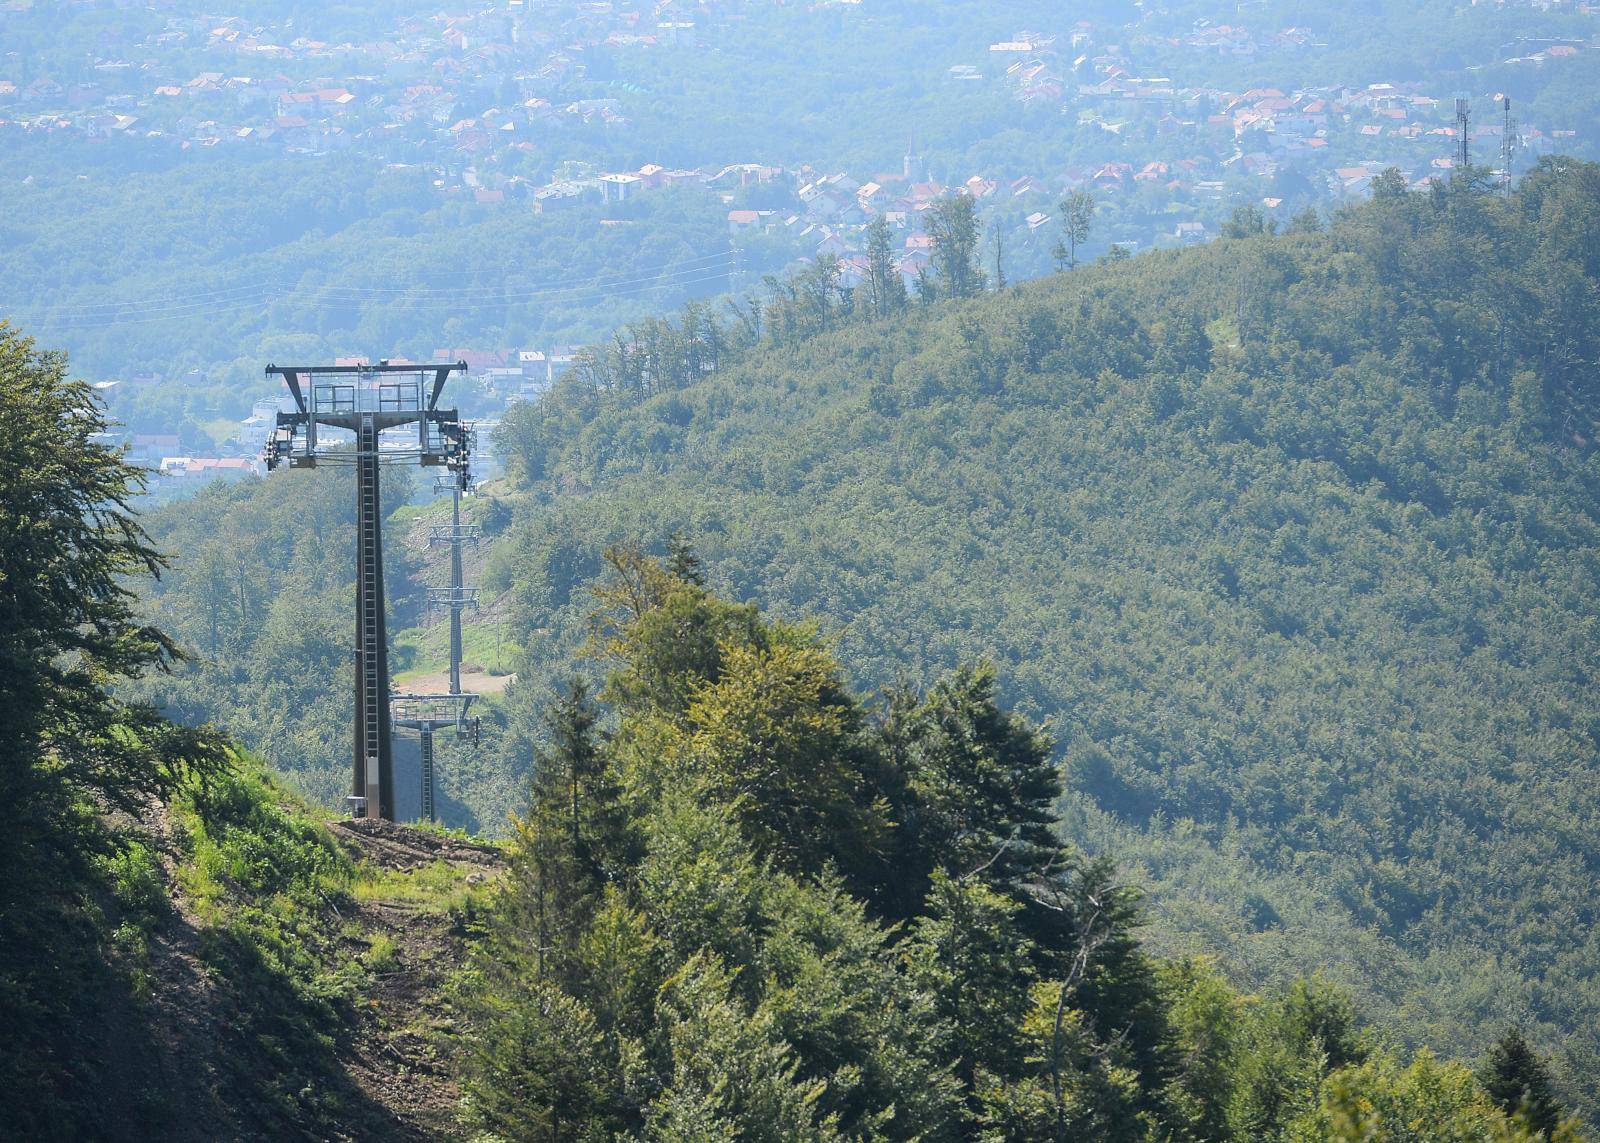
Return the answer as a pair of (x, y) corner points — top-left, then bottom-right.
(0, 325), (498, 1140)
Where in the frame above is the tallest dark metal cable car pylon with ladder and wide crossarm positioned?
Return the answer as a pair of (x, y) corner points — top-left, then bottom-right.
(266, 362), (469, 821)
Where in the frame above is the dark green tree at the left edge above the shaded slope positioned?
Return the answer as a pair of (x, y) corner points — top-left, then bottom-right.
(0, 323), (221, 813)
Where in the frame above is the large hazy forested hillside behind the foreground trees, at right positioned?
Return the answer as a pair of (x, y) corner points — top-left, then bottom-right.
(476, 162), (1600, 1106)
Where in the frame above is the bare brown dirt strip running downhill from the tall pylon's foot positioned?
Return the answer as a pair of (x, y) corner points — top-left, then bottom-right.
(324, 820), (501, 1140)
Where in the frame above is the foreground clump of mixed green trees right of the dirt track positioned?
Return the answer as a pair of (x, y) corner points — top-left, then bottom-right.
(462, 544), (1571, 1143)
